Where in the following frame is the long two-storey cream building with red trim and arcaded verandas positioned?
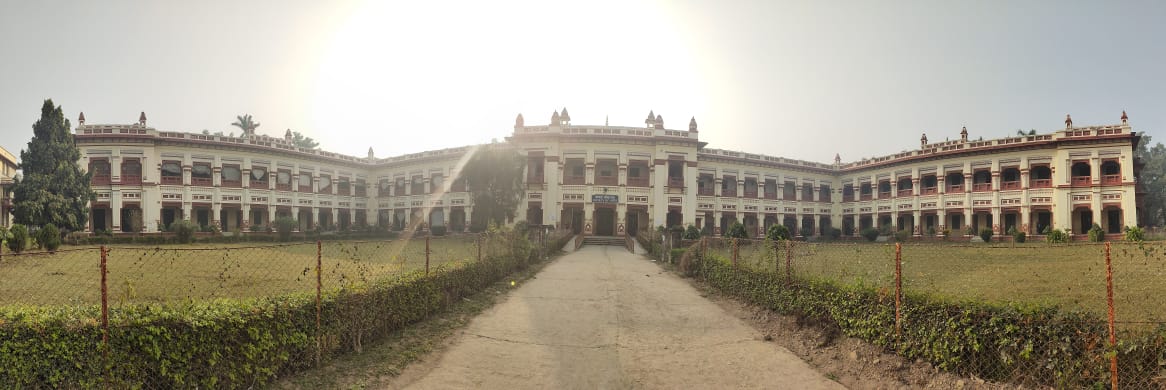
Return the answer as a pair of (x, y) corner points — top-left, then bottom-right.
(76, 109), (1139, 236)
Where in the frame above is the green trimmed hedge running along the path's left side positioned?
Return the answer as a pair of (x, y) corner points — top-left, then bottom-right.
(0, 228), (569, 389)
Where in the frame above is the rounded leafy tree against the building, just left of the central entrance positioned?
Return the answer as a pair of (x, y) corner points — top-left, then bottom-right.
(458, 145), (526, 231)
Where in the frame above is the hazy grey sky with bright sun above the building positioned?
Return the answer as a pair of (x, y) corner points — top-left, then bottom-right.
(0, 0), (1166, 162)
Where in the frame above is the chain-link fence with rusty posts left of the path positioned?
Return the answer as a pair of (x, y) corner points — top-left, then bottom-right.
(0, 229), (569, 389)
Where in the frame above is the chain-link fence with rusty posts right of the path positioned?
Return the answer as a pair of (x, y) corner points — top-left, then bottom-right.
(675, 237), (1166, 389)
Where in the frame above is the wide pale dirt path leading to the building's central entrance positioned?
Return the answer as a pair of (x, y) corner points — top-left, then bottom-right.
(389, 246), (843, 389)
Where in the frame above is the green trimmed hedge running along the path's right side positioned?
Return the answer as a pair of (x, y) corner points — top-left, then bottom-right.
(688, 246), (1166, 388)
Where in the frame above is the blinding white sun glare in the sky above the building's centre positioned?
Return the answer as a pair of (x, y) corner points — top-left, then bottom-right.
(312, 1), (705, 156)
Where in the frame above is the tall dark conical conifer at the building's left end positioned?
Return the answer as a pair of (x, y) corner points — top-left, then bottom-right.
(13, 99), (97, 231)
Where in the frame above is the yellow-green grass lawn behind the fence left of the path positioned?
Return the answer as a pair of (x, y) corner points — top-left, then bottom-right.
(0, 237), (493, 306)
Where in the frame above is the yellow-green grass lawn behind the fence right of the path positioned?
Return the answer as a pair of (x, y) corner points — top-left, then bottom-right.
(710, 242), (1166, 325)
